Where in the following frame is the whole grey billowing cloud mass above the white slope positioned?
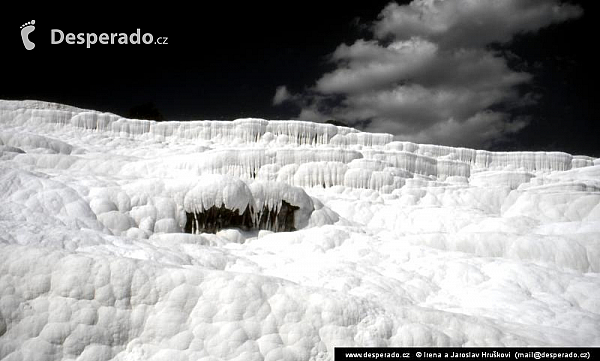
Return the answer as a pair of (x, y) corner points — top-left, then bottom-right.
(273, 0), (582, 148)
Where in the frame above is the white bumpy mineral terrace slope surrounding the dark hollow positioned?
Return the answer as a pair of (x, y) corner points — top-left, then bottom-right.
(0, 101), (600, 361)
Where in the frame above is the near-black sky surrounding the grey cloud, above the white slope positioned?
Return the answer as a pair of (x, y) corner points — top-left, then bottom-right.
(0, 0), (600, 156)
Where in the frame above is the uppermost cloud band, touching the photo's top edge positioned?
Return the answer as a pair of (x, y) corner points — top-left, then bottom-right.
(373, 0), (583, 48)
